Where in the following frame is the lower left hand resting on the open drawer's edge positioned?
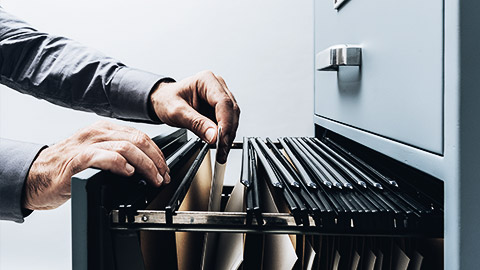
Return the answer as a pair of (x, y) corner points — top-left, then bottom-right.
(22, 121), (170, 210)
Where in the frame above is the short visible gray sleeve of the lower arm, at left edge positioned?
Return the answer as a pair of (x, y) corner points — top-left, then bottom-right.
(0, 139), (45, 222)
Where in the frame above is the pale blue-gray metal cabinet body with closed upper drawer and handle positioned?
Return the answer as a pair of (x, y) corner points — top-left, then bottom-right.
(314, 0), (480, 269)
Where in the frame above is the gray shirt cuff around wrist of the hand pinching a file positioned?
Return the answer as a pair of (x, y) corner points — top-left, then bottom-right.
(109, 67), (173, 123)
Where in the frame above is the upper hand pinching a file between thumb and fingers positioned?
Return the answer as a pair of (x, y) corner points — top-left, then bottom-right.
(150, 71), (240, 163)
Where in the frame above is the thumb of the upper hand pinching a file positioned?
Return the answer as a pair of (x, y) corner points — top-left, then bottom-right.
(180, 106), (217, 144)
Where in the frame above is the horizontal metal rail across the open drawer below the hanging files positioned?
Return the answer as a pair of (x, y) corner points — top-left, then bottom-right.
(110, 210), (439, 237)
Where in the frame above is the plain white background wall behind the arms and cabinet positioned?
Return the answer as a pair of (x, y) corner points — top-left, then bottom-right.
(0, 0), (314, 270)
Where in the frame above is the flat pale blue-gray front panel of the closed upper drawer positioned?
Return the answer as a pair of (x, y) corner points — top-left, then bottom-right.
(315, 0), (443, 154)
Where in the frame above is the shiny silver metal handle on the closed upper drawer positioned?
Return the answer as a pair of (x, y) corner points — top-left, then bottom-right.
(315, 44), (362, 71)
